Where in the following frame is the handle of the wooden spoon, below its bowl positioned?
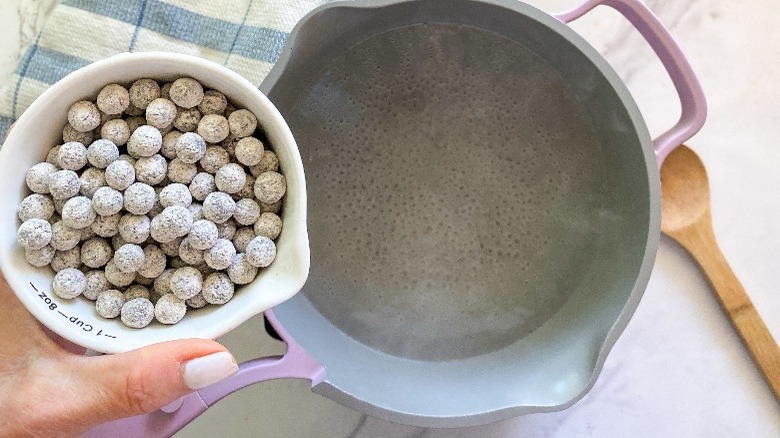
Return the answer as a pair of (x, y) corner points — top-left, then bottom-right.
(672, 221), (780, 401)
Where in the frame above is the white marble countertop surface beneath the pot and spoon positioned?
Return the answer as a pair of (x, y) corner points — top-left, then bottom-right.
(0, 0), (780, 438)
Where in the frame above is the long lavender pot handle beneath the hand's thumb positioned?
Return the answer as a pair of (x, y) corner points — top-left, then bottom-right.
(81, 310), (325, 438)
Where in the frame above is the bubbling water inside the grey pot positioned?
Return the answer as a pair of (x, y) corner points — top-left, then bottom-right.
(285, 24), (606, 360)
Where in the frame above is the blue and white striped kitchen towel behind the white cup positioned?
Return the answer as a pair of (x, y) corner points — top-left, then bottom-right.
(0, 0), (328, 144)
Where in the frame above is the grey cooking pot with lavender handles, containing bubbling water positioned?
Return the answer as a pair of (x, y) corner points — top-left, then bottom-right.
(82, 0), (706, 436)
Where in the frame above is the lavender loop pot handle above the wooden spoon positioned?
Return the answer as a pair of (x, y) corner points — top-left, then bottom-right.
(555, 0), (707, 165)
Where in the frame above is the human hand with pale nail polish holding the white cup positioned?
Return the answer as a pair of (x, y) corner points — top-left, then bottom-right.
(0, 123), (238, 437)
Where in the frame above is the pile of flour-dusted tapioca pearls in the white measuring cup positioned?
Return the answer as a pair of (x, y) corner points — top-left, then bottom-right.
(17, 78), (286, 328)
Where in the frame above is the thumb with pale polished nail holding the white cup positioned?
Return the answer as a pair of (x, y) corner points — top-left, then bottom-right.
(69, 339), (238, 427)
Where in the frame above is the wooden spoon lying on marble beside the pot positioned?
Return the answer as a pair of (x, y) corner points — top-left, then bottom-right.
(661, 146), (780, 401)
